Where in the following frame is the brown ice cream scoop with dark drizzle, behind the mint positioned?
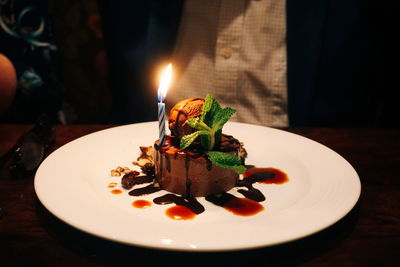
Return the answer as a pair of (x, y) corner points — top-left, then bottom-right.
(168, 98), (204, 139)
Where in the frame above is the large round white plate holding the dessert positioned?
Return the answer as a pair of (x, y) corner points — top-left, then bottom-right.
(35, 122), (361, 251)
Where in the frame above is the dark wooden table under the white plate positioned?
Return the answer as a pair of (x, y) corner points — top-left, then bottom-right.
(0, 125), (400, 266)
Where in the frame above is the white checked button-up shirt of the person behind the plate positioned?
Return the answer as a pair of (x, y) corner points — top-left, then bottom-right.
(166, 0), (288, 127)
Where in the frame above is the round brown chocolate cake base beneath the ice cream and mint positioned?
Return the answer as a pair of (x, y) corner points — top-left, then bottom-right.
(154, 135), (244, 197)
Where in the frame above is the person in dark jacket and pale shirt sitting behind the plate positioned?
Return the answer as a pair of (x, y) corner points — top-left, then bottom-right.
(99, 0), (399, 127)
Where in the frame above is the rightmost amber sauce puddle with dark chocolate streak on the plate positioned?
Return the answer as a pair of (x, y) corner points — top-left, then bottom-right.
(243, 167), (289, 184)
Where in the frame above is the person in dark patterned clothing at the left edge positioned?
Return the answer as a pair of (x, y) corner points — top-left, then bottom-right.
(0, 0), (64, 123)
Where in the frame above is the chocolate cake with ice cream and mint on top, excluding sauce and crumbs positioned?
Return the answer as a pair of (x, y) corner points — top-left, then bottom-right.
(153, 95), (246, 197)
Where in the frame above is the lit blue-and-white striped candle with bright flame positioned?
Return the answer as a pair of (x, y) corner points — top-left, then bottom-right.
(157, 64), (172, 146)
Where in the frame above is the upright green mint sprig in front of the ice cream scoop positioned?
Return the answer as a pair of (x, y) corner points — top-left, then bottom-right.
(180, 94), (236, 150)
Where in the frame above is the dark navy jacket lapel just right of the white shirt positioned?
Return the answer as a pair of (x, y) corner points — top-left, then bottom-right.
(286, 0), (328, 126)
